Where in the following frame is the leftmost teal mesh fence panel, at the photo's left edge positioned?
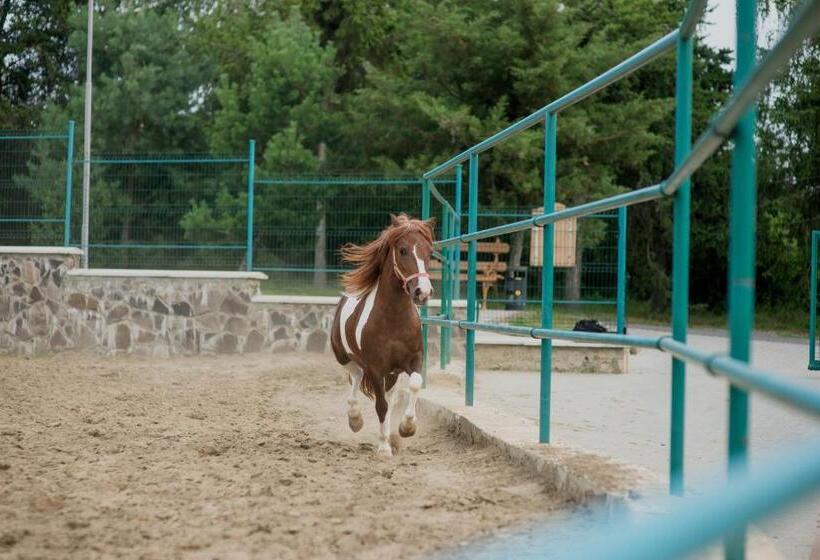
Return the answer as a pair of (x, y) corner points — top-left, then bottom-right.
(0, 121), (74, 246)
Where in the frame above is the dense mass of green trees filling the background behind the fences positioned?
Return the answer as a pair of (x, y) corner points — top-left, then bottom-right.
(14, 0), (820, 318)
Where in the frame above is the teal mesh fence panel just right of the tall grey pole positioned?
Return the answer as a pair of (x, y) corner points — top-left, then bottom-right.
(77, 155), (248, 270)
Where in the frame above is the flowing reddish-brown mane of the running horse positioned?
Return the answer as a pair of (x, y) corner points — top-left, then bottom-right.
(341, 213), (433, 294)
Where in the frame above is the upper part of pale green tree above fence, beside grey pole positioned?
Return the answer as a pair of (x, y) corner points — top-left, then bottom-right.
(65, 2), (207, 154)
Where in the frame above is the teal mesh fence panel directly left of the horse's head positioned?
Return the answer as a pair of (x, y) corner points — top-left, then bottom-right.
(253, 176), (447, 295)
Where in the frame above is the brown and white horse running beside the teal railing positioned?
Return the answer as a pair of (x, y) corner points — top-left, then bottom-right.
(330, 214), (433, 457)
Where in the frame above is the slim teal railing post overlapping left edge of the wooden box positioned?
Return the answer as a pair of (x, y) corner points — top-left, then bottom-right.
(538, 113), (558, 443)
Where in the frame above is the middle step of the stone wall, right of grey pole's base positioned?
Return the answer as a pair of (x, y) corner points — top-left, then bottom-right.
(65, 269), (269, 357)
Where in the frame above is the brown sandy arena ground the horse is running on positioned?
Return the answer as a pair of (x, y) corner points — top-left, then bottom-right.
(0, 353), (564, 558)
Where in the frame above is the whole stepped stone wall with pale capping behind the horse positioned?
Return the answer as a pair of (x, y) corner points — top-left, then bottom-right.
(0, 247), (464, 357)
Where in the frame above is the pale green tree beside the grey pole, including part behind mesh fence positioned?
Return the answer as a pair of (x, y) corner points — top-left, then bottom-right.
(26, 2), (219, 264)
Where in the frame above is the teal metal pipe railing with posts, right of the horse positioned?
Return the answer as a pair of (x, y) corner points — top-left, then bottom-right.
(424, 0), (820, 559)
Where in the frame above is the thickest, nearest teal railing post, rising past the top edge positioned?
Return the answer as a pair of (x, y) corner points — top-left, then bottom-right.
(724, 0), (757, 560)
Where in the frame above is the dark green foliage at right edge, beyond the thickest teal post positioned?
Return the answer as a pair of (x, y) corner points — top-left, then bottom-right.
(758, 0), (820, 309)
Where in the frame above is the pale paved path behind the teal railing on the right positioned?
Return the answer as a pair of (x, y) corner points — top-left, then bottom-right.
(448, 328), (820, 559)
